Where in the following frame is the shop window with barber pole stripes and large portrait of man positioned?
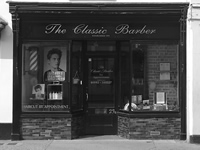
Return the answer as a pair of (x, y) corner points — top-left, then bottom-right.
(21, 42), (69, 112)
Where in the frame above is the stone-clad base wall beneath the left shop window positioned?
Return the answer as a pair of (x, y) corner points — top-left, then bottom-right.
(20, 116), (84, 140)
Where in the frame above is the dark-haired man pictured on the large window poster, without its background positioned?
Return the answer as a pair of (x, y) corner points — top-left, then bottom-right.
(44, 48), (65, 82)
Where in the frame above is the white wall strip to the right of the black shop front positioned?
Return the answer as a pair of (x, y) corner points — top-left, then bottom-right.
(187, 0), (200, 139)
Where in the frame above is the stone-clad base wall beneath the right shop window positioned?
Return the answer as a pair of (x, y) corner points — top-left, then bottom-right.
(118, 116), (181, 139)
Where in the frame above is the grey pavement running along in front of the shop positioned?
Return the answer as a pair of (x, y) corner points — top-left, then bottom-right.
(0, 136), (200, 150)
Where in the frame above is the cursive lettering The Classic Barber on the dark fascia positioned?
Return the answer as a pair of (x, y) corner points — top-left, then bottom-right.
(45, 23), (156, 37)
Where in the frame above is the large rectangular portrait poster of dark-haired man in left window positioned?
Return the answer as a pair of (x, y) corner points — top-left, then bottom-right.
(43, 46), (67, 82)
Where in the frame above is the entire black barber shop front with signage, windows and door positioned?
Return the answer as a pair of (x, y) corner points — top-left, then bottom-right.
(9, 2), (187, 140)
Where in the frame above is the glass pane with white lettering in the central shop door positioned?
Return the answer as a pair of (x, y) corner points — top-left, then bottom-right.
(88, 56), (115, 107)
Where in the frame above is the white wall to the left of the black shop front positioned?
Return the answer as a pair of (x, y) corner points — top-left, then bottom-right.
(0, 0), (13, 123)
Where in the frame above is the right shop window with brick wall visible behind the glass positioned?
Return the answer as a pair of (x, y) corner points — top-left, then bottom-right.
(120, 42), (179, 112)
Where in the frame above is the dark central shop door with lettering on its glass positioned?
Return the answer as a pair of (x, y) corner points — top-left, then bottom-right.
(86, 55), (117, 135)
